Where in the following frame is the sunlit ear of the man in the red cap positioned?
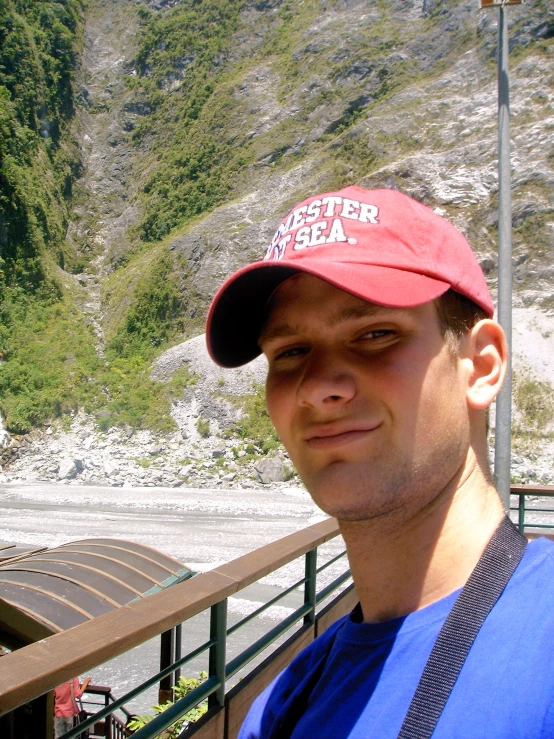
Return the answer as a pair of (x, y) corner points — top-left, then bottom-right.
(464, 319), (508, 410)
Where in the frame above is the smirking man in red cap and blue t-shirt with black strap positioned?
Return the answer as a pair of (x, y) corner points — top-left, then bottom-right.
(207, 187), (554, 739)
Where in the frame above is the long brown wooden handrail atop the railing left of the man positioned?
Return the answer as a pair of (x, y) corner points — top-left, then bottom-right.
(0, 518), (339, 714)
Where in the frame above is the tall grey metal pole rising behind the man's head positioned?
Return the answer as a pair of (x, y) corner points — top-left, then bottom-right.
(494, 6), (512, 510)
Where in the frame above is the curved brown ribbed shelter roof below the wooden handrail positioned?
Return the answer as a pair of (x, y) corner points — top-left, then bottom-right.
(0, 539), (194, 649)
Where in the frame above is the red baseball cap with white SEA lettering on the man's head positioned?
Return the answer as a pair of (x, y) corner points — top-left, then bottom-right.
(206, 186), (494, 367)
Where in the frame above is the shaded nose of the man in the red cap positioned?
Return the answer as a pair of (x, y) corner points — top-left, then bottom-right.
(297, 351), (356, 410)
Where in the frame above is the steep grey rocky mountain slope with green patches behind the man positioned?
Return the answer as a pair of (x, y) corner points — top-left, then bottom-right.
(0, 0), (554, 484)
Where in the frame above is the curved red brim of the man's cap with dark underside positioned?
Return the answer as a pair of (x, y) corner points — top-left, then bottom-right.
(206, 259), (451, 367)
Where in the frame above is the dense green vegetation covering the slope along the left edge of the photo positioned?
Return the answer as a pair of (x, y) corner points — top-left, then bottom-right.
(0, 0), (192, 433)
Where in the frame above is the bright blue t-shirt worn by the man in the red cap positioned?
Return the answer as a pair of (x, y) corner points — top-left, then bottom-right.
(239, 539), (554, 739)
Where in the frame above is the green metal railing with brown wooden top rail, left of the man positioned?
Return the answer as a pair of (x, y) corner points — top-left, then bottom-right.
(0, 519), (350, 739)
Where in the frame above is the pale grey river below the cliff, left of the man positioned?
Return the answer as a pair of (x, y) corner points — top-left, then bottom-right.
(0, 484), (342, 712)
